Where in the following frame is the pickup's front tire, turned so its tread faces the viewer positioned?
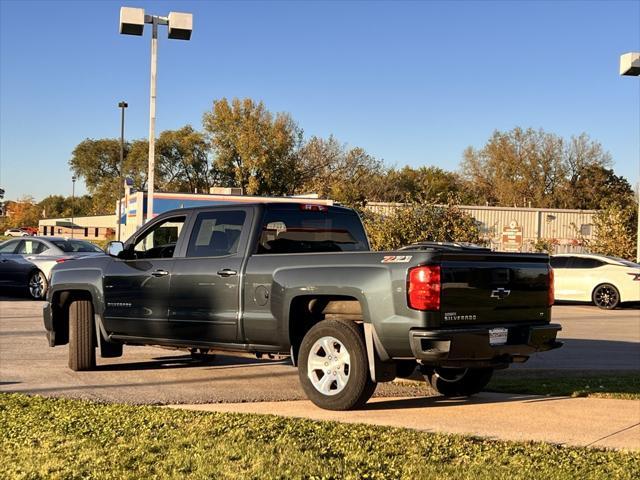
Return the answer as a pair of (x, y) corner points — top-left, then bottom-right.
(69, 300), (96, 372)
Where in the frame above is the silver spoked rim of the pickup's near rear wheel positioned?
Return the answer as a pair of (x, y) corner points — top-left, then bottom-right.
(307, 336), (351, 396)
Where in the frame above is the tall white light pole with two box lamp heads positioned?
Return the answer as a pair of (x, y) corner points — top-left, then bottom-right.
(120, 7), (193, 221)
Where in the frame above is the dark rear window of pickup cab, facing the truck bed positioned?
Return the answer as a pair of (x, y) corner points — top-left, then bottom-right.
(257, 209), (369, 254)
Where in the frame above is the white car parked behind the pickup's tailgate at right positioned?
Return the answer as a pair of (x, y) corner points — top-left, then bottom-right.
(551, 253), (640, 310)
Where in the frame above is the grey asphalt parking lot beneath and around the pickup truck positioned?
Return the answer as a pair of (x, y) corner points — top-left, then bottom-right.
(0, 297), (640, 404)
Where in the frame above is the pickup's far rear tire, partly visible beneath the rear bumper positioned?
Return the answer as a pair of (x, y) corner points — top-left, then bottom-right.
(425, 367), (493, 397)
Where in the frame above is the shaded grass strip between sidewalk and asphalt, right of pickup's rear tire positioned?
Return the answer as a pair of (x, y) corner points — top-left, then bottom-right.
(485, 371), (640, 400)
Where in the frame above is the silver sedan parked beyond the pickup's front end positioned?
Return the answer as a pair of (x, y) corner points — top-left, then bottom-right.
(0, 237), (104, 299)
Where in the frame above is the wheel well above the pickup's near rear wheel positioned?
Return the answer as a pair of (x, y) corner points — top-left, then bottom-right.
(289, 295), (364, 364)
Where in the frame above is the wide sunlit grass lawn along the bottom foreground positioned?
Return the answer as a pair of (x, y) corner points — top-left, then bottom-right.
(0, 394), (640, 480)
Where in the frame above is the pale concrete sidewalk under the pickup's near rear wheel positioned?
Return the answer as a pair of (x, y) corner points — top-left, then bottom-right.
(171, 393), (640, 450)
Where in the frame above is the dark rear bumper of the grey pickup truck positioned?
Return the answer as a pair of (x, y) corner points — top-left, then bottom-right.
(410, 324), (562, 367)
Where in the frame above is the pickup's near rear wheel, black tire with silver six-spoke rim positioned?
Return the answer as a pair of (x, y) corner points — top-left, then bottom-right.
(298, 320), (376, 410)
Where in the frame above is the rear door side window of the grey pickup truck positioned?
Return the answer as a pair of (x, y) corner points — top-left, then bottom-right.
(187, 210), (247, 257)
